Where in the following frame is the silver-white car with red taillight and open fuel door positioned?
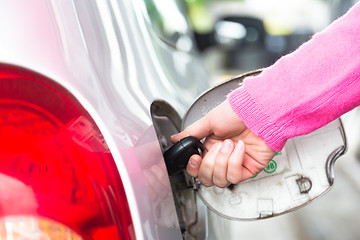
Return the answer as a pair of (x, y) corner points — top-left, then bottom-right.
(0, 0), (346, 240)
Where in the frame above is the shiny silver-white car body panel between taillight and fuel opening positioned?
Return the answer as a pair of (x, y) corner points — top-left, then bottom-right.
(0, 0), (208, 239)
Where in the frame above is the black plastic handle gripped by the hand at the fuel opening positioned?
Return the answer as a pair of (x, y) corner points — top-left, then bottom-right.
(164, 136), (204, 176)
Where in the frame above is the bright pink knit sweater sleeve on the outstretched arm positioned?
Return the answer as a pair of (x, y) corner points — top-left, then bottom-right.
(228, 3), (360, 151)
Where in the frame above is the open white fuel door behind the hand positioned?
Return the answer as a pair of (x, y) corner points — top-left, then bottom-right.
(163, 71), (346, 220)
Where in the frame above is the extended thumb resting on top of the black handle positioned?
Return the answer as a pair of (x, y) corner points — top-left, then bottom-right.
(170, 115), (212, 143)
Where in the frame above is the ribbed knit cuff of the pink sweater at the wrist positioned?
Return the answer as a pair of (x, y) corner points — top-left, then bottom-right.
(227, 87), (287, 152)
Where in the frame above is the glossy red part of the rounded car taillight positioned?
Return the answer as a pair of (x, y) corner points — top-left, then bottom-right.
(0, 65), (134, 239)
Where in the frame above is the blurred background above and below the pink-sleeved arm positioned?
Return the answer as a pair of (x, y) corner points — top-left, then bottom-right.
(184, 0), (360, 240)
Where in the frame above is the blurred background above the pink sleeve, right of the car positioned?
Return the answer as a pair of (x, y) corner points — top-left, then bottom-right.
(183, 0), (356, 84)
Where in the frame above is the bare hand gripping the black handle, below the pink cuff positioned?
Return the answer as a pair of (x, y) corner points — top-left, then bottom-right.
(171, 100), (276, 187)
